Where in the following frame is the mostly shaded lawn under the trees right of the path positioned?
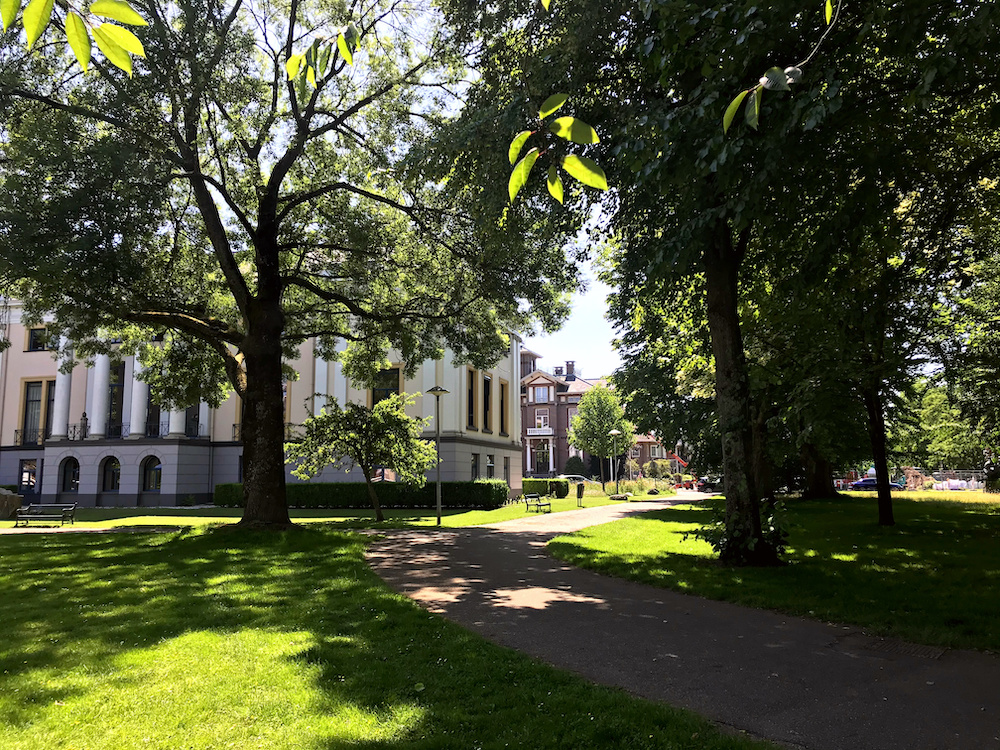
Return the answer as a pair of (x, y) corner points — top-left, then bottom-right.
(548, 493), (1000, 652)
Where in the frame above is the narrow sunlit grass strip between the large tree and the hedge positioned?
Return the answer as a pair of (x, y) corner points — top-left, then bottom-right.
(0, 495), (616, 530)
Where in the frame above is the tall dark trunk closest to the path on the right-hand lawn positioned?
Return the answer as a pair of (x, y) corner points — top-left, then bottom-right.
(704, 226), (779, 565)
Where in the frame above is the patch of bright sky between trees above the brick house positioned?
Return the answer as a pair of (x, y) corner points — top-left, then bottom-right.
(524, 269), (621, 378)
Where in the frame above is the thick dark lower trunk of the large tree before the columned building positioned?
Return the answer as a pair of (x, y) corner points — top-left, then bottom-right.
(240, 304), (291, 528)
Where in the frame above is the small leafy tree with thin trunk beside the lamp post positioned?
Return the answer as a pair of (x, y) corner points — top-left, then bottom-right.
(285, 394), (437, 521)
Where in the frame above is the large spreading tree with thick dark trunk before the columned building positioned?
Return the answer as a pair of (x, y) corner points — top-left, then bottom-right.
(0, 0), (576, 525)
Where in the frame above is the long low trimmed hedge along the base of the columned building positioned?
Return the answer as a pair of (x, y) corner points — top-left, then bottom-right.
(214, 479), (510, 510)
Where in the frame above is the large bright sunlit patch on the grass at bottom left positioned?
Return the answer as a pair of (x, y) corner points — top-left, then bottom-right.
(0, 629), (424, 750)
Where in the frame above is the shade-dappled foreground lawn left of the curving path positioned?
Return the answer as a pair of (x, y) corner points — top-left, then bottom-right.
(0, 516), (770, 750)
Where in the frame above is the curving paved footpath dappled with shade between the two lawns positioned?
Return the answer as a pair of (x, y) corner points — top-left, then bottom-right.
(369, 496), (1000, 750)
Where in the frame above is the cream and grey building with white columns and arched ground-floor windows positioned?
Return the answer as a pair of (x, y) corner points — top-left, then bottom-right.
(0, 303), (522, 506)
